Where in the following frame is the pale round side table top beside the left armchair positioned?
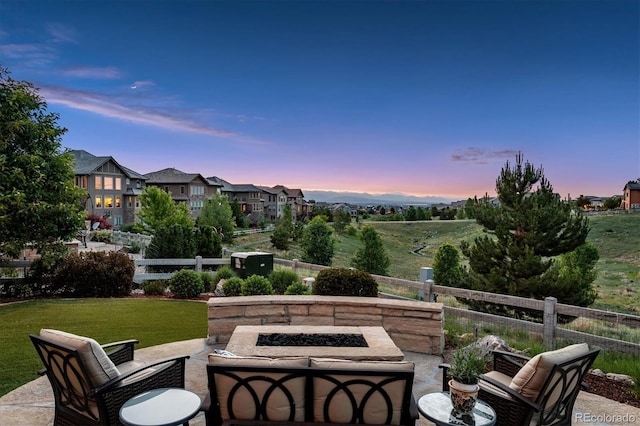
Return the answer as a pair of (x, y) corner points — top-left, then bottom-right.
(120, 388), (202, 426)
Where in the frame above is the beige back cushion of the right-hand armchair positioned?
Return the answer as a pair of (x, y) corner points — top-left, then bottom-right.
(509, 343), (589, 401)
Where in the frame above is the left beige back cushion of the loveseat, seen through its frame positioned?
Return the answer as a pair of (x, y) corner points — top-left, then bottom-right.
(209, 354), (309, 422)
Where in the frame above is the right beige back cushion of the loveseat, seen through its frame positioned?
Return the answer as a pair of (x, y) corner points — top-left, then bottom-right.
(309, 358), (414, 425)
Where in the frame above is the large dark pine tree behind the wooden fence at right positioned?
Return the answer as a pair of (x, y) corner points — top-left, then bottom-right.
(463, 154), (589, 310)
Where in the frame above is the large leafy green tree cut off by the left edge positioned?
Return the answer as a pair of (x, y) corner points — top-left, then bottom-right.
(0, 67), (85, 258)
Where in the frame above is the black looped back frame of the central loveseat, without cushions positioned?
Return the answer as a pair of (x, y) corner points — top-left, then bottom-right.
(203, 364), (418, 426)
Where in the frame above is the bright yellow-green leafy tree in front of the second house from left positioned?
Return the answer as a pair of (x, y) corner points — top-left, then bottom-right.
(136, 186), (193, 235)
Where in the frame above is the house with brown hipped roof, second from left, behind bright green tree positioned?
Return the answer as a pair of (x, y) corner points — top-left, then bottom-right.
(145, 168), (222, 217)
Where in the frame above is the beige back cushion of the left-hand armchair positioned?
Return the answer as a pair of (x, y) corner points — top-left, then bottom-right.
(40, 328), (120, 387)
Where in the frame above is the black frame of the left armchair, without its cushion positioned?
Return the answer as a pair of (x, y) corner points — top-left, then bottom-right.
(29, 334), (189, 425)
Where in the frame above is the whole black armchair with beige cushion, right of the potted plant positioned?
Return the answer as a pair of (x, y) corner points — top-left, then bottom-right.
(443, 343), (600, 426)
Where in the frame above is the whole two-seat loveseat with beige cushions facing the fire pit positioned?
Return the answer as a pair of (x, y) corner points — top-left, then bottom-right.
(203, 354), (418, 426)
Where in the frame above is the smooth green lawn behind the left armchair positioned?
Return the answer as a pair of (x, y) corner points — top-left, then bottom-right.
(0, 298), (207, 395)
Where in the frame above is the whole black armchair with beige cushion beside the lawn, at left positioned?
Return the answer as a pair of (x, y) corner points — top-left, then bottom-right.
(29, 329), (189, 425)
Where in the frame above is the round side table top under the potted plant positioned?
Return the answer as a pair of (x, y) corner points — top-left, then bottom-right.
(418, 392), (496, 426)
